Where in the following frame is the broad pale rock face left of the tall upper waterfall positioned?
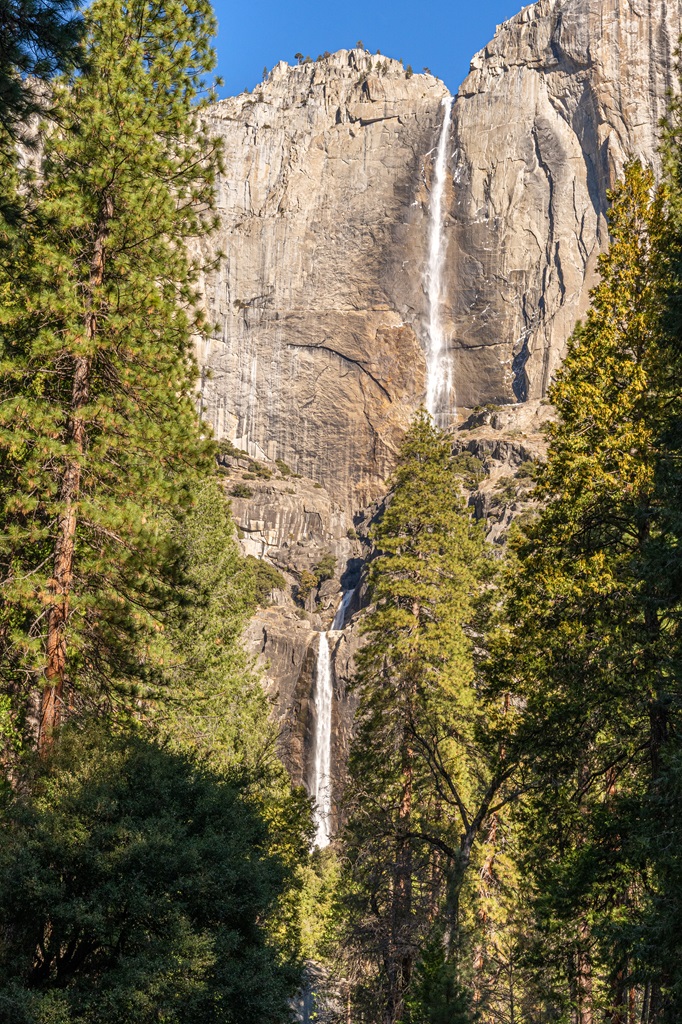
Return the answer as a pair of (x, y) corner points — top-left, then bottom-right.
(200, 50), (445, 508)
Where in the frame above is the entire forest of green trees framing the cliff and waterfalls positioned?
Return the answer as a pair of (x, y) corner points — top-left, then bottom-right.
(0, 0), (682, 1024)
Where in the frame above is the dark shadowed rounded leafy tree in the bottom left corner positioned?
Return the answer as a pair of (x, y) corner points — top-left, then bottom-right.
(0, 729), (298, 1024)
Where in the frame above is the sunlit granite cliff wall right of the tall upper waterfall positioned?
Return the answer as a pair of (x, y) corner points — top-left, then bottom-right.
(447, 0), (682, 406)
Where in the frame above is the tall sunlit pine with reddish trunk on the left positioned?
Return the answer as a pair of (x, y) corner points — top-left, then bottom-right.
(0, 0), (219, 745)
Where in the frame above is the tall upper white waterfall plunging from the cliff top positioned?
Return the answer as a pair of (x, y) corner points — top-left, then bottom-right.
(426, 96), (455, 427)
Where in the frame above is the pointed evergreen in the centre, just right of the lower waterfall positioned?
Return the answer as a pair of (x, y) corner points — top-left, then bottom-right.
(343, 414), (511, 1024)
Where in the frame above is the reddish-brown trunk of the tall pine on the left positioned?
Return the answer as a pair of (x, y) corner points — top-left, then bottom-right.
(38, 197), (114, 753)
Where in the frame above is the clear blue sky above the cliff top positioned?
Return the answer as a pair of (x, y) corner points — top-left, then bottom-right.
(214, 0), (524, 96)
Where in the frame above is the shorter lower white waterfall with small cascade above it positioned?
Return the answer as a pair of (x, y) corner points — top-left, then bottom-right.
(310, 590), (353, 849)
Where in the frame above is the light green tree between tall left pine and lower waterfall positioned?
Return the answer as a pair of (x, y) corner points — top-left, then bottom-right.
(150, 479), (272, 769)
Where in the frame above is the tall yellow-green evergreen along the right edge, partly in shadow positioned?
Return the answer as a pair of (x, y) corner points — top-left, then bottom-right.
(489, 163), (682, 1024)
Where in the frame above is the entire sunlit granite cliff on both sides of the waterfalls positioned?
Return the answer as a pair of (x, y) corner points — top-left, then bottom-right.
(192, 0), (682, 831)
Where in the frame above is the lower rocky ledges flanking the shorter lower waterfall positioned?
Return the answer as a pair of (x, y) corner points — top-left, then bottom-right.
(219, 451), (366, 829)
